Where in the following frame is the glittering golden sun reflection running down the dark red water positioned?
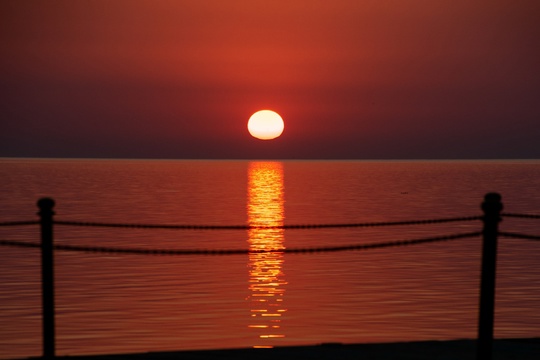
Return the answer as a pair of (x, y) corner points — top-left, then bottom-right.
(247, 162), (287, 348)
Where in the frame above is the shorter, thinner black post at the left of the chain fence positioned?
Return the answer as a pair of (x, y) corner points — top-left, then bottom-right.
(37, 198), (55, 359)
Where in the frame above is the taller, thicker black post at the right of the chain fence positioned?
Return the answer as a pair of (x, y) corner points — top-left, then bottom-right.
(476, 193), (503, 360)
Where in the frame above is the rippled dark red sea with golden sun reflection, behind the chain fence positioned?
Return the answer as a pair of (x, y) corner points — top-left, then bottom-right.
(0, 158), (540, 359)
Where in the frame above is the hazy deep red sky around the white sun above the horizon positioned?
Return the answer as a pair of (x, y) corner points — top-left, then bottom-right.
(0, 0), (540, 159)
